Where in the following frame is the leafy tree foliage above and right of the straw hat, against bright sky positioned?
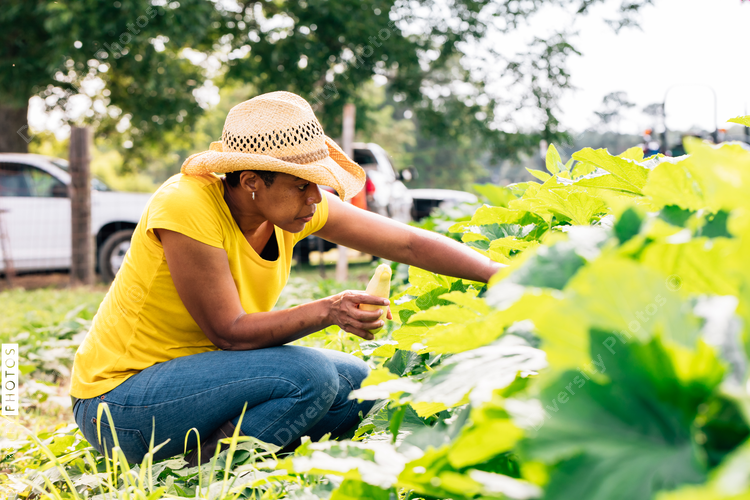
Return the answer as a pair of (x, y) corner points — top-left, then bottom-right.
(226, 0), (651, 162)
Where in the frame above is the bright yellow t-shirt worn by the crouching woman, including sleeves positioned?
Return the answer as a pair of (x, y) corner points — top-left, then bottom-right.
(70, 174), (328, 399)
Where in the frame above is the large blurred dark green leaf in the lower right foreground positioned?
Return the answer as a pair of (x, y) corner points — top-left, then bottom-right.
(523, 332), (723, 500)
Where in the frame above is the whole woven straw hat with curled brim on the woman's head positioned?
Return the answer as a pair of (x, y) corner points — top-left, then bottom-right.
(181, 91), (366, 200)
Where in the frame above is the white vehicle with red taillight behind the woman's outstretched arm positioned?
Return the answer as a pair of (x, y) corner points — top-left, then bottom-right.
(295, 142), (413, 264)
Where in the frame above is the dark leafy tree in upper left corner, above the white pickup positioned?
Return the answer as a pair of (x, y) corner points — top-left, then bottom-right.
(0, 0), (229, 152)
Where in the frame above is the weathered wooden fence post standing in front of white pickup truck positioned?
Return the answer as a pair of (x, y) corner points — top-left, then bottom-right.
(68, 127), (94, 285)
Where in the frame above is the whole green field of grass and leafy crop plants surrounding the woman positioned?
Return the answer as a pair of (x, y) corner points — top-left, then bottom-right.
(0, 139), (750, 500)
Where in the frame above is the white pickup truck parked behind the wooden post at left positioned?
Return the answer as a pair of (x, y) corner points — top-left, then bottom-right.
(0, 153), (151, 281)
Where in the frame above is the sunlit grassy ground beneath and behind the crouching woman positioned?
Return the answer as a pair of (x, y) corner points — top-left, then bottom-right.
(0, 264), (402, 499)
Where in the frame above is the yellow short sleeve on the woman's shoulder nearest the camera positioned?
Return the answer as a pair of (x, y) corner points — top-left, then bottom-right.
(146, 176), (225, 248)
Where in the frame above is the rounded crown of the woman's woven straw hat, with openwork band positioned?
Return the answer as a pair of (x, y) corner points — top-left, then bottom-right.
(222, 91), (328, 163)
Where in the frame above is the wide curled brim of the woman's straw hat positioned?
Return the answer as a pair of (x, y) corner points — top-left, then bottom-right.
(180, 136), (367, 200)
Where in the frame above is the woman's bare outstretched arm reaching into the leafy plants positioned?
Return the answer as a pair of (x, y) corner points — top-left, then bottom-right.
(315, 193), (504, 283)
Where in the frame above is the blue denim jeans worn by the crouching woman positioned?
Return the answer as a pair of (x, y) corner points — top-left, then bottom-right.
(73, 345), (374, 463)
